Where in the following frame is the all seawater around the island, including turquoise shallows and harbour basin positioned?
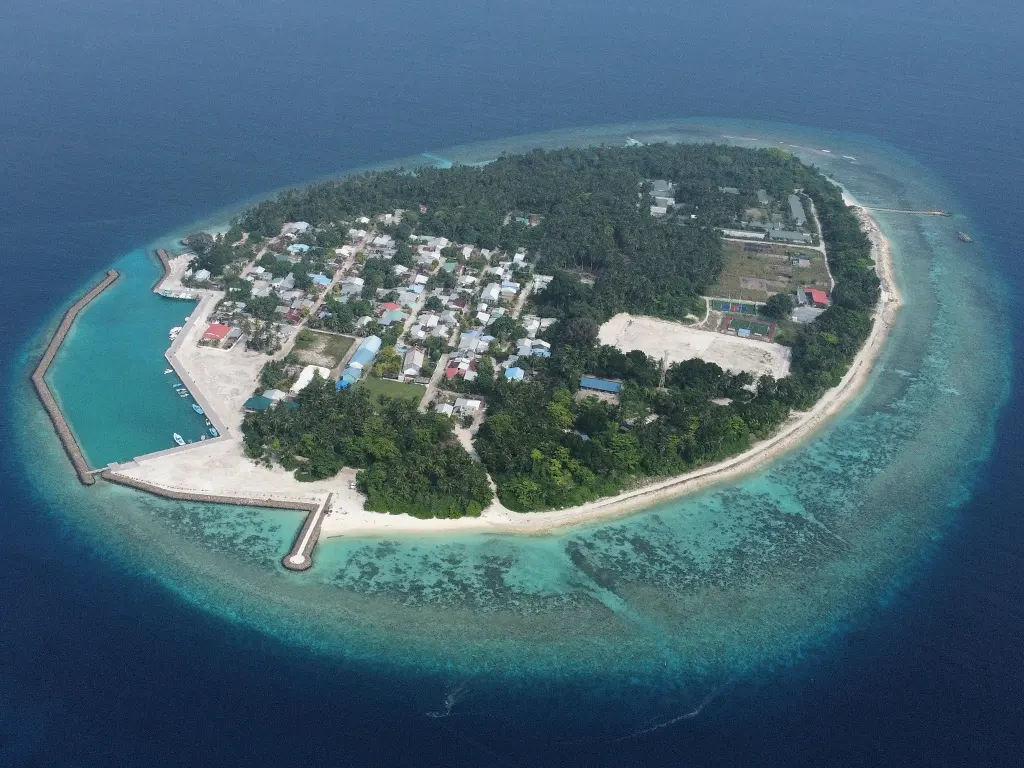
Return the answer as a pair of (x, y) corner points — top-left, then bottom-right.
(0, 0), (1024, 766)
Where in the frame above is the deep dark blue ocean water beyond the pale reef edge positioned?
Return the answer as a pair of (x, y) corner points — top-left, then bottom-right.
(0, 0), (1024, 766)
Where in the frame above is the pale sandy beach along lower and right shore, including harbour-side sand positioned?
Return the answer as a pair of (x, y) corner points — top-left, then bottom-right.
(108, 201), (900, 538)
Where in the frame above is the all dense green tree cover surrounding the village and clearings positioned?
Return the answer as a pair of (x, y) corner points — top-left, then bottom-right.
(241, 144), (879, 514)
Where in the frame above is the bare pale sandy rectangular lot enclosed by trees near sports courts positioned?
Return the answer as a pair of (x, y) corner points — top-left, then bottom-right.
(598, 312), (790, 379)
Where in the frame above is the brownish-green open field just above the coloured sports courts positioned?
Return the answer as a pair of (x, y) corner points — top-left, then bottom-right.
(708, 242), (829, 301)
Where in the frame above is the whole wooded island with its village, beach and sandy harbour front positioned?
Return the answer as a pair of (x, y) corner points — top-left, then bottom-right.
(92, 143), (899, 569)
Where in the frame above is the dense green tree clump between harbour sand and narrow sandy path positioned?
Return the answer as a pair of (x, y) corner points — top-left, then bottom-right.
(243, 376), (494, 517)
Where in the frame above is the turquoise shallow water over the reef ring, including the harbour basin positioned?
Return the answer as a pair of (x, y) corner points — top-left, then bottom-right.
(13, 120), (1010, 702)
